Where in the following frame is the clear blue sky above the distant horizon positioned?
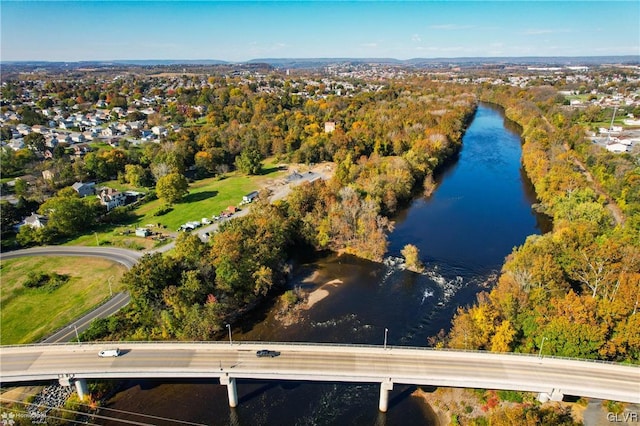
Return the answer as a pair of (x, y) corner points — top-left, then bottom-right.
(0, 0), (640, 61)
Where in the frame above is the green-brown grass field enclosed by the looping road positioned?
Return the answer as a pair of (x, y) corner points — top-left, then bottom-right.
(0, 256), (126, 345)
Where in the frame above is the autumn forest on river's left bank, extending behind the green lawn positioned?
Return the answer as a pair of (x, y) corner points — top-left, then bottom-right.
(85, 81), (476, 340)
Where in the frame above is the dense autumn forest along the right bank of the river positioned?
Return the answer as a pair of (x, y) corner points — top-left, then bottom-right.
(439, 87), (640, 362)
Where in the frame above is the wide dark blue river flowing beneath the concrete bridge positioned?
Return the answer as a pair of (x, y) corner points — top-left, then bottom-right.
(102, 104), (549, 425)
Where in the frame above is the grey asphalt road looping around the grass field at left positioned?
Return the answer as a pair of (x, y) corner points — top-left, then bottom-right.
(0, 246), (143, 343)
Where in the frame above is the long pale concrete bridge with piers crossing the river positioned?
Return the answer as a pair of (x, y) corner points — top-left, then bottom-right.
(0, 342), (640, 411)
